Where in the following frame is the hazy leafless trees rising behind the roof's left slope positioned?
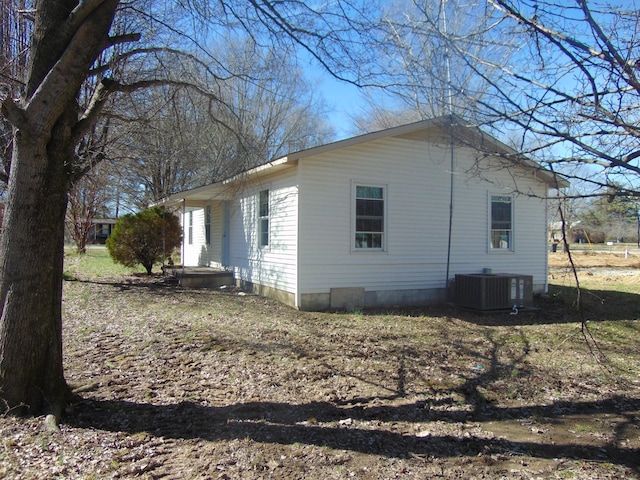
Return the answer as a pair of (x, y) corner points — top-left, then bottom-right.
(112, 39), (332, 209)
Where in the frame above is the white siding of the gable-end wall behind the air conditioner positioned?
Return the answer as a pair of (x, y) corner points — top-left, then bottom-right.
(298, 138), (546, 294)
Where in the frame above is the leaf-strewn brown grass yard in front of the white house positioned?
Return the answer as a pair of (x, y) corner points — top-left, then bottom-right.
(0, 250), (640, 479)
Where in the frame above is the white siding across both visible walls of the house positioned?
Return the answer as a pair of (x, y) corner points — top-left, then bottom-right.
(183, 125), (547, 305)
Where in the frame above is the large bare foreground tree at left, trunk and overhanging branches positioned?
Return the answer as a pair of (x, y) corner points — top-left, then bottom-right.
(0, 0), (371, 414)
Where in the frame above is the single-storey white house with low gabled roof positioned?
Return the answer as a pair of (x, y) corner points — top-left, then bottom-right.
(163, 117), (558, 310)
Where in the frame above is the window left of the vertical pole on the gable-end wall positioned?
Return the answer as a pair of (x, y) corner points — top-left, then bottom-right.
(355, 185), (385, 250)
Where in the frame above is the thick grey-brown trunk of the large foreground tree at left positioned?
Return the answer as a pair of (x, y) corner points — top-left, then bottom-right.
(0, 0), (118, 415)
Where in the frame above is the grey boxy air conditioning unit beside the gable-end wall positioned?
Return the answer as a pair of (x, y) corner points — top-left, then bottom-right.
(456, 273), (533, 310)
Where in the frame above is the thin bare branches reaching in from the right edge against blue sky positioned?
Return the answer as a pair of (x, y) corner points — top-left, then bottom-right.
(448, 0), (640, 198)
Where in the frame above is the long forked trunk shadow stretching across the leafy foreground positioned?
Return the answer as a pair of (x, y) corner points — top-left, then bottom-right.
(66, 398), (640, 472)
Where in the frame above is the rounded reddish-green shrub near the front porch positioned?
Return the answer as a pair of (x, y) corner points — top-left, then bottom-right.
(107, 207), (182, 275)
